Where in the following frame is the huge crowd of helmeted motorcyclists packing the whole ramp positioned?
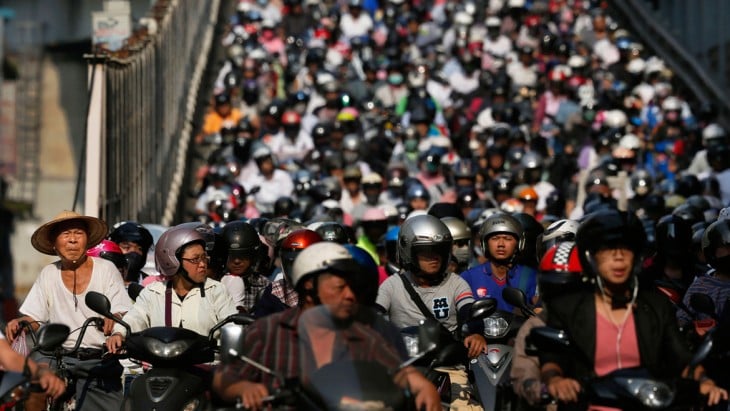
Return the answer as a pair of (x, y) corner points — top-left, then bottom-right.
(0, 0), (730, 410)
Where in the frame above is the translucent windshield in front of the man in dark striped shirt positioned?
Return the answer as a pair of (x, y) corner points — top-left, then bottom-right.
(297, 305), (405, 410)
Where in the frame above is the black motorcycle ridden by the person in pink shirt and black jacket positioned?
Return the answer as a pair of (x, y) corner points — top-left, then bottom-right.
(528, 327), (713, 411)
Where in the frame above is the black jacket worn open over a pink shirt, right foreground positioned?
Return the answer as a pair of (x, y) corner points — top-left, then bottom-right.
(540, 291), (691, 380)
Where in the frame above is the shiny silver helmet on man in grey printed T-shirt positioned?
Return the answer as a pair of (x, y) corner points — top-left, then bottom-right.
(396, 214), (454, 273)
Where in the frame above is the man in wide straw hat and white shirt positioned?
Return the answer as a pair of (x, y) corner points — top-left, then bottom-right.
(5, 211), (131, 410)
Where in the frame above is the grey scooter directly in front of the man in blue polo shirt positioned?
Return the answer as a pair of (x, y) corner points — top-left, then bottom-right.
(469, 287), (535, 411)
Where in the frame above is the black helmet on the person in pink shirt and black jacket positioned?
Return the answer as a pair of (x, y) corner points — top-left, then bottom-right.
(575, 209), (646, 277)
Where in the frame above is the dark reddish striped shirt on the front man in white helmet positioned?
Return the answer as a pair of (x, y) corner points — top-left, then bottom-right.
(222, 307), (400, 389)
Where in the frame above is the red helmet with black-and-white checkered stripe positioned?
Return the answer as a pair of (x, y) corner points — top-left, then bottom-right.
(537, 241), (583, 299)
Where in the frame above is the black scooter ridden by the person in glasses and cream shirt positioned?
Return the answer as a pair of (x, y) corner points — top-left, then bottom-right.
(86, 291), (253, 410)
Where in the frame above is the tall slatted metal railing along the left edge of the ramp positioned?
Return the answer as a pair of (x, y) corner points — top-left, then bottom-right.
(84, 0), (221, 225)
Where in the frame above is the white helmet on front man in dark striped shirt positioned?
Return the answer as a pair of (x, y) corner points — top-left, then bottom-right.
(291, 241), (360, 292)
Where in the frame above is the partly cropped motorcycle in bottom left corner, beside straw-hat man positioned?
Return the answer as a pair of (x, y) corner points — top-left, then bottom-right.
(0, 321), (70, 410)
